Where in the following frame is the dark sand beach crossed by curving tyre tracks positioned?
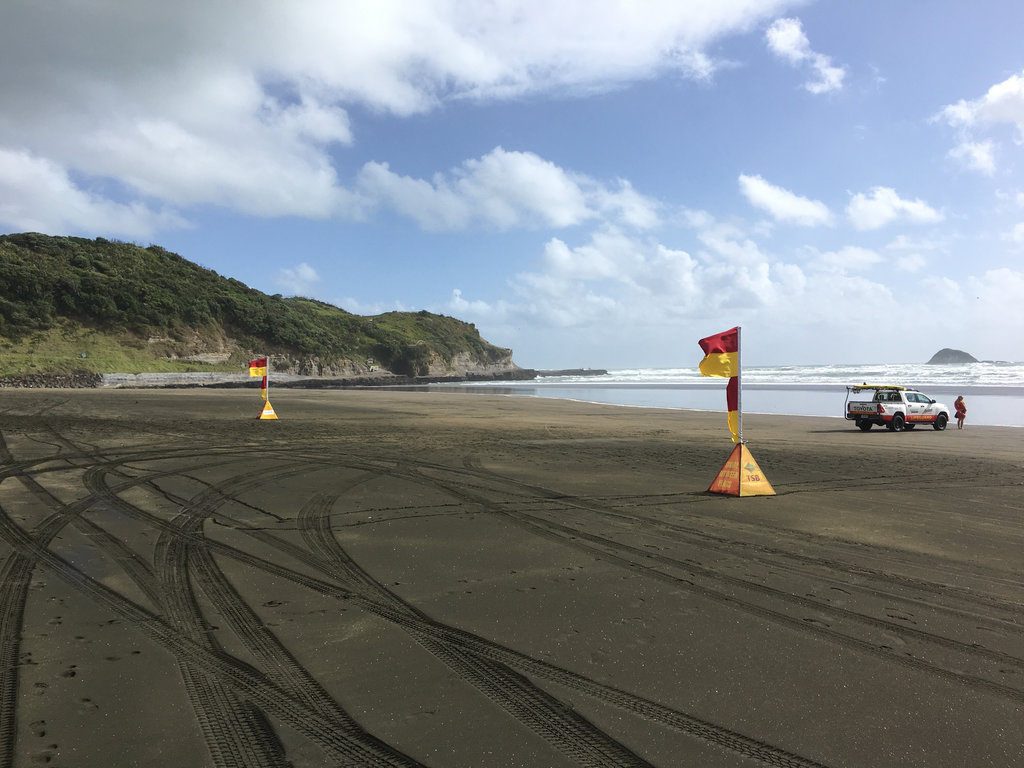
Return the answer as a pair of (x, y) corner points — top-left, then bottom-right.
(0, 390), (1024, 768)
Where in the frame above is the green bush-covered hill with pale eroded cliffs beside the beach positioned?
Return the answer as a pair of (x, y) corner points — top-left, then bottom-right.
(0, 233), (515, 377)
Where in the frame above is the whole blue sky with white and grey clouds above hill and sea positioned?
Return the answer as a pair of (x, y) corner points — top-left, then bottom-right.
(0, 0), (1024, 369)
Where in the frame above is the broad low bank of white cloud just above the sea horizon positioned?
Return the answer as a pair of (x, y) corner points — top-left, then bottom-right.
(450, 212), (1024, 368)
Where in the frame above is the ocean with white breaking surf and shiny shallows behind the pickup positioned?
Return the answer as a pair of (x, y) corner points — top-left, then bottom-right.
(429, 362), (1024, 428)
